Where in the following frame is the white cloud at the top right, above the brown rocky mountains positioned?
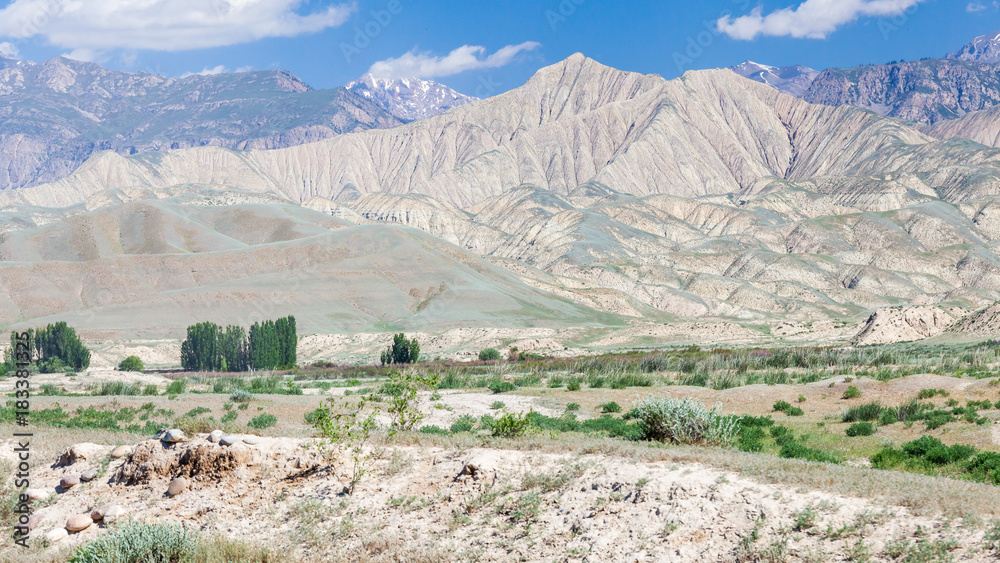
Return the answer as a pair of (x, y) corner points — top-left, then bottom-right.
(716, 0), (925, 39)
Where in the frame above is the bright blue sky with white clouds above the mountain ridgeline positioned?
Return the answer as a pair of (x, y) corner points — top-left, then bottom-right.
(0, 0), (1000, 97)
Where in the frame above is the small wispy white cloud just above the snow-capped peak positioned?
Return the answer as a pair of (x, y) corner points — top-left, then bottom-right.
(368, 41), (541, 78)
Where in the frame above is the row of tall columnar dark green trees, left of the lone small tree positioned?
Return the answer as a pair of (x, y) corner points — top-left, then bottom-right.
(181, 315), (298, 371)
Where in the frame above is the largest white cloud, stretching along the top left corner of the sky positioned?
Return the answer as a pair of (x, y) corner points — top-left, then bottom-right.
(0, 0), (356, 51)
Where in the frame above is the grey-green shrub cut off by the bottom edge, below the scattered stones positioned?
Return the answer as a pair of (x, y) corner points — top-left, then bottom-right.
(69, 521), (198, 563)
